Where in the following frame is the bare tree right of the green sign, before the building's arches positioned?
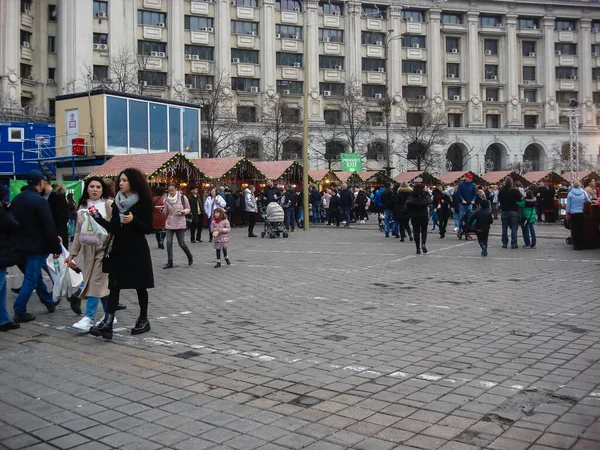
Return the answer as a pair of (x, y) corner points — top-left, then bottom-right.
(395, 99), (448, 173)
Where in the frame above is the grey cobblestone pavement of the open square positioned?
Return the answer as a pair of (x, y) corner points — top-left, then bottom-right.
(0, 225), (600, 450)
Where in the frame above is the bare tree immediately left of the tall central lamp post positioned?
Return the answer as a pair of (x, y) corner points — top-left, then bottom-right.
(262, 96), (302, 161)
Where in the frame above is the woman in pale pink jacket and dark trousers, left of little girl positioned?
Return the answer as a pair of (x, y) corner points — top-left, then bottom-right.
(160, 183), (194, 269)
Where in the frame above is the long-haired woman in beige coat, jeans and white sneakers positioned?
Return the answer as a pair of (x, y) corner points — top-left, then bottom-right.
(65, 177), (117, 332)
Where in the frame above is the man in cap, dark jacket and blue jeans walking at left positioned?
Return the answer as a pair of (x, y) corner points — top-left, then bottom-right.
(11, 170), (61, 323)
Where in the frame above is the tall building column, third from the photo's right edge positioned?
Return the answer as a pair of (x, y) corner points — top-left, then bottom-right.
(505, 14), (523, 128)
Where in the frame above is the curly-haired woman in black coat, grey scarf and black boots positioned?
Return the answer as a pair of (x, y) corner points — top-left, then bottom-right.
(90, 168), (154, 339)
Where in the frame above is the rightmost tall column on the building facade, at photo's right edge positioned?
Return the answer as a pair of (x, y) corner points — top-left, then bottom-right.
(578, 18), (596, 129)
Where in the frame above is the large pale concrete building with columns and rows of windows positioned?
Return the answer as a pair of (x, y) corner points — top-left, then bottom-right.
(0, 0), (600, 176)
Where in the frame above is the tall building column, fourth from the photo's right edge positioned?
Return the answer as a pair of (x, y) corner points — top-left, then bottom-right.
(467, 11), (485, 127)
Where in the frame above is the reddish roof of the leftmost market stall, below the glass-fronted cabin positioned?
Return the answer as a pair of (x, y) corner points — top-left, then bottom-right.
(88, 152), (206, 181)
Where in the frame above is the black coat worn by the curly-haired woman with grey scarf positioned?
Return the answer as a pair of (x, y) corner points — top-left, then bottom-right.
(96, 200), (154, 289)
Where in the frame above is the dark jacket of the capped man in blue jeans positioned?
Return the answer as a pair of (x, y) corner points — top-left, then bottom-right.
(10, 188), (61, 255)
